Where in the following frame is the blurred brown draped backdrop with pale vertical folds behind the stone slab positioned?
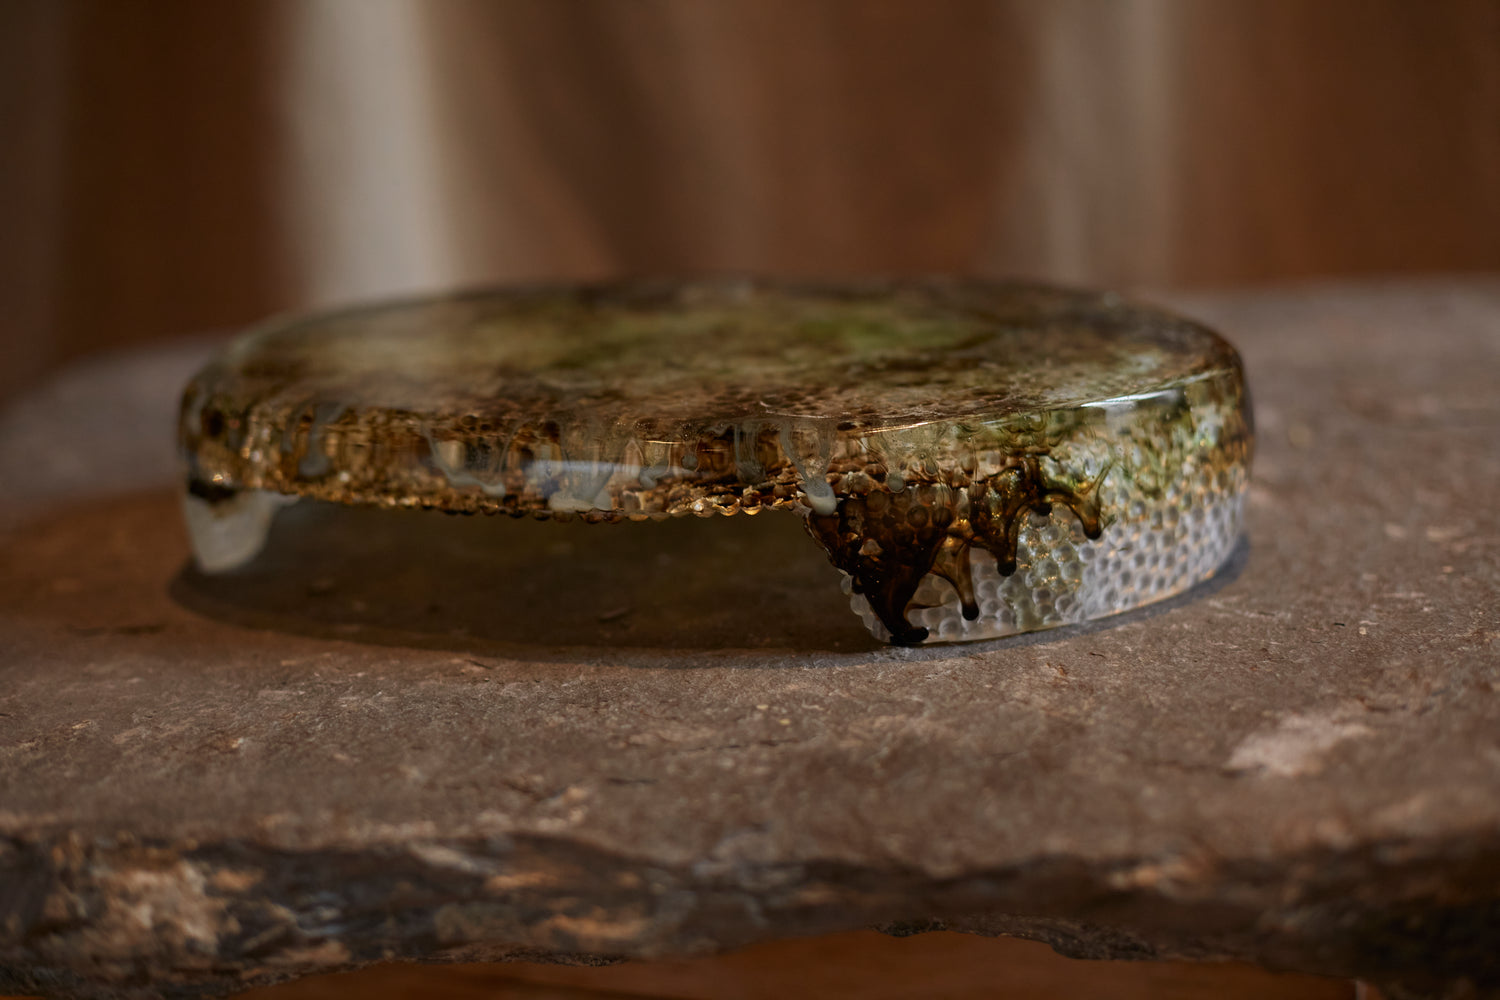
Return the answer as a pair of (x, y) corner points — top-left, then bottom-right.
(0, 0), (1500, 394)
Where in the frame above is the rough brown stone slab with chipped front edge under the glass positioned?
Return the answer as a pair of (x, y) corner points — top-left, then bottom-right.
(0, 280), (1500, 996)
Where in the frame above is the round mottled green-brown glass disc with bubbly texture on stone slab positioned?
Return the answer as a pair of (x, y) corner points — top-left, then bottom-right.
(179, 280), (1253, 645)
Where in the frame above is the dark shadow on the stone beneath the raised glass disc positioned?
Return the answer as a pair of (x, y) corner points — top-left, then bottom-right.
(171, 501), (1250, 660)
